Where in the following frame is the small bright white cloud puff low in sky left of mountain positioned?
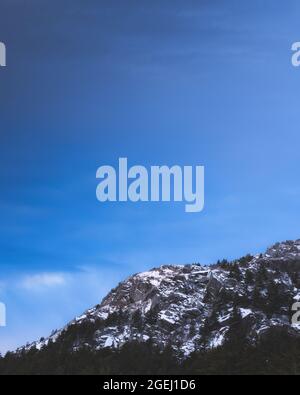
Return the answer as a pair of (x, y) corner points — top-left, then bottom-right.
(21, 273), (66, 291)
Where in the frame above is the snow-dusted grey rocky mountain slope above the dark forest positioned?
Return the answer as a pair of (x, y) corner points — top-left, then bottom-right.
(21, 240), (300, 357)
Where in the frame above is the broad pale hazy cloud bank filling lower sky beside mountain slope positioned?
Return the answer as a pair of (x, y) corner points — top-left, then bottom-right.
(0, 265), (129, 353)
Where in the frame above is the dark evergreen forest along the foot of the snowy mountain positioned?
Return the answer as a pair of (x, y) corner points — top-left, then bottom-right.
(0, 327), (300, 375)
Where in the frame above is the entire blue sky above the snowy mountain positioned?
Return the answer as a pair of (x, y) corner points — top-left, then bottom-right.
(0, 0), (300, 351)
